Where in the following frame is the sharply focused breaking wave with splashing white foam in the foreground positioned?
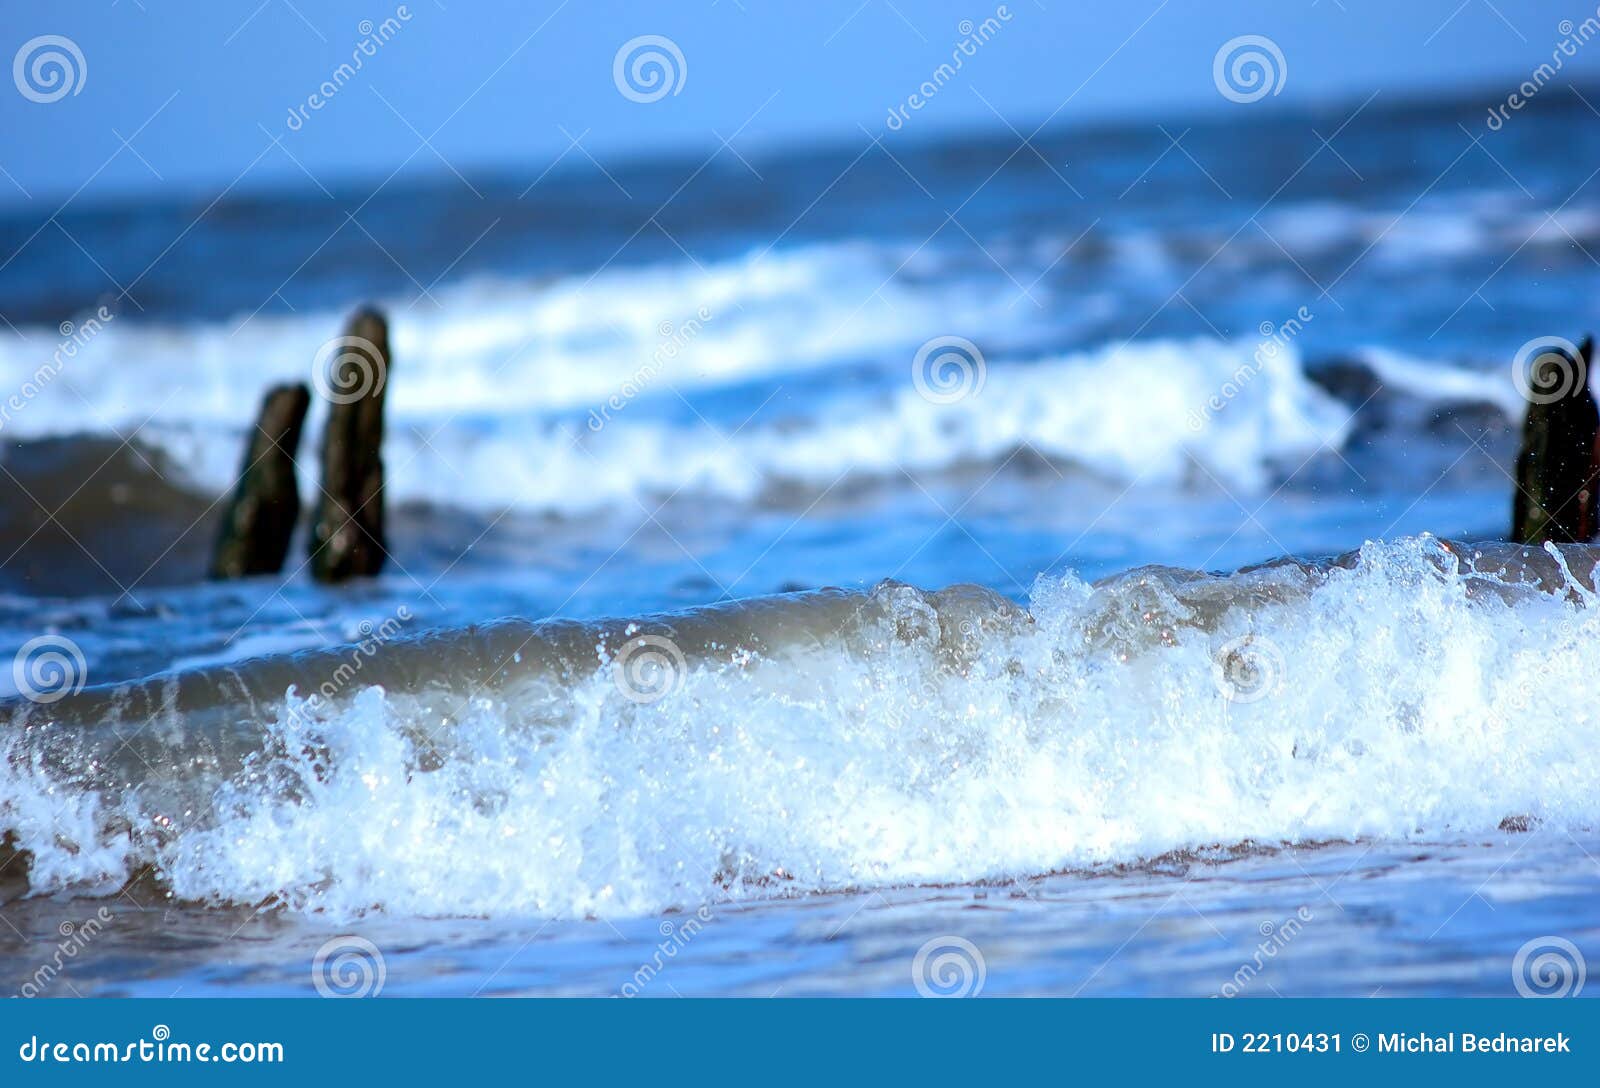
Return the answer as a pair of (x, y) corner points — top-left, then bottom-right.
(0, 538), (1600, 917)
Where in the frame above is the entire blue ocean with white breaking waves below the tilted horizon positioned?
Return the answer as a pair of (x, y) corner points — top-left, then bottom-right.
(0, 84), (1600, 997)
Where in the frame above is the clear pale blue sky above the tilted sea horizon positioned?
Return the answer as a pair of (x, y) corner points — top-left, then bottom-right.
(0, 0), (1600, 214)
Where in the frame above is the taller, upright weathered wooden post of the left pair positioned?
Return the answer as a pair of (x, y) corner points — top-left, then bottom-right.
(310, 307), (389, 582)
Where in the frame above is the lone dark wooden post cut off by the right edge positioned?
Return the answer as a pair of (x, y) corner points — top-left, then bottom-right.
(1510, 336), (1600, 544)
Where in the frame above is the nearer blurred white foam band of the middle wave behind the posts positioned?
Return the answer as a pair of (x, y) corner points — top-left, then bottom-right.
(121, 339), (1349, 512)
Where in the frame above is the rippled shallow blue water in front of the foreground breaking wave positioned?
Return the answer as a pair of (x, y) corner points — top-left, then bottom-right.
(0, 829), (1600, 997)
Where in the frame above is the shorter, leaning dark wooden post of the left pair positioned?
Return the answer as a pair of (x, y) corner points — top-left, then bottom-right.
(211, 384), (310, 579)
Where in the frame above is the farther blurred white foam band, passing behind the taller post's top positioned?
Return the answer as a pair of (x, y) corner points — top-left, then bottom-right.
(0, 243), (1027, 438)
